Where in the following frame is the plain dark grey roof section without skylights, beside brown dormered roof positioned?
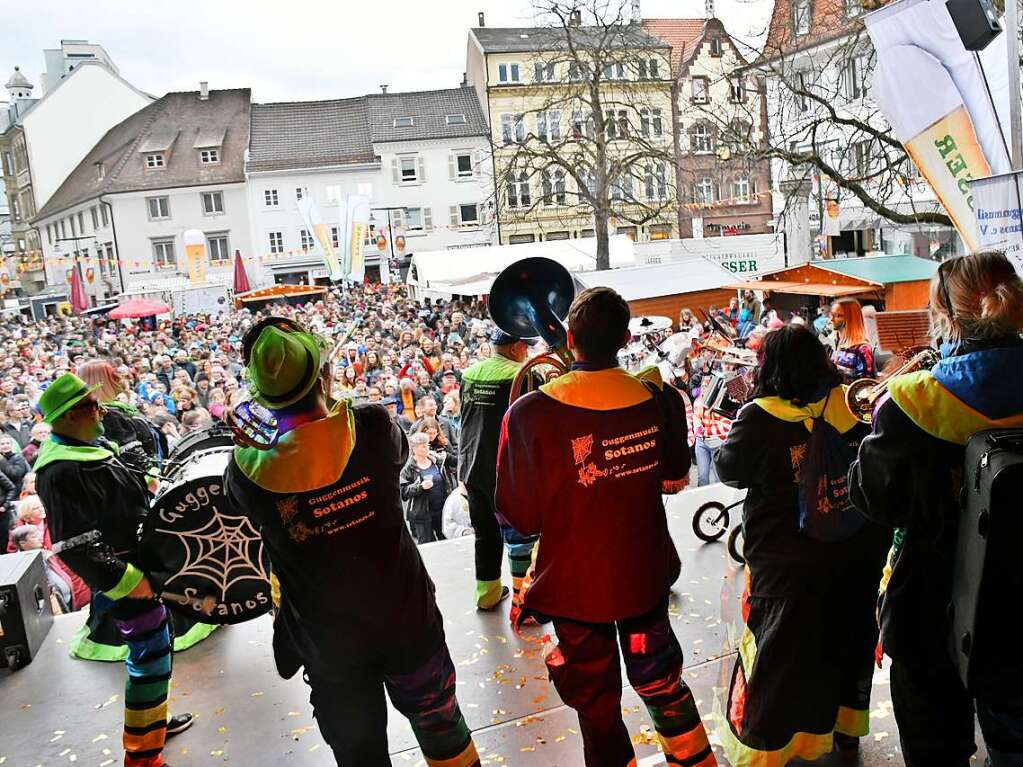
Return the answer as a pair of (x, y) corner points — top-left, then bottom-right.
(249, 96), (374, 171)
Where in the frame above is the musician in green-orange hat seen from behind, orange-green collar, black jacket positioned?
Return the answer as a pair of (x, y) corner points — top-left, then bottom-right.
(224, 325), (480, 767)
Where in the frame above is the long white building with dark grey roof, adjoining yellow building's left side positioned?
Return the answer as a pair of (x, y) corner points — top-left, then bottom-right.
(247, 88), (493, 283)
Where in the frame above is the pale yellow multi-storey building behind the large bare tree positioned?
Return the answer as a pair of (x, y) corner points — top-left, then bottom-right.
(466, 14), (677, 244)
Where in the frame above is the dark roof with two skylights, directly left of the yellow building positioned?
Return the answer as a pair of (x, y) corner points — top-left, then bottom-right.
(366, 87), (489, 141)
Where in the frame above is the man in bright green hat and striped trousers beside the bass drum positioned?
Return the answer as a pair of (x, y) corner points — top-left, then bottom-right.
(34, 373), (192, 767)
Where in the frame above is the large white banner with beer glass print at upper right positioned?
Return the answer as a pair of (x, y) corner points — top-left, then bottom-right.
(863, 0), (1010, 251)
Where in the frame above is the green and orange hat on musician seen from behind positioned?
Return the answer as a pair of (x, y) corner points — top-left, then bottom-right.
(248, 325), (320, 410)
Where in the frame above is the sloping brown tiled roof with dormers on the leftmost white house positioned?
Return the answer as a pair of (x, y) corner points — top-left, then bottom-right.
(34, 90), (251, 221)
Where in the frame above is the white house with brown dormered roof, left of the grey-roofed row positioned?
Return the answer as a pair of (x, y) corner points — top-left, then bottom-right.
(33, 88), (252, 303)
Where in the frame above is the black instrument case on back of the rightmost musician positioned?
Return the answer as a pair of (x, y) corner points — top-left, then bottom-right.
(949, 428), (1023, 696)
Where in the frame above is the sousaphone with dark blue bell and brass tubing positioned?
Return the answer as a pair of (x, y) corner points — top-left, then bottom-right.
(490, 257), (576, 404)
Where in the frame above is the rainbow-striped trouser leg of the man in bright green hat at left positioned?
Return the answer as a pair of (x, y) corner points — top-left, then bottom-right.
(116, 602), (172, 767)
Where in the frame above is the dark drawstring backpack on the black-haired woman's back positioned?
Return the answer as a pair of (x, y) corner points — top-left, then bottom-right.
(799, 394), (866, 543)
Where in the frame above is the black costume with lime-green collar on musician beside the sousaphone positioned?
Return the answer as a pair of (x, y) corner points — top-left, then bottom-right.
(458, 354), (536, 607)
